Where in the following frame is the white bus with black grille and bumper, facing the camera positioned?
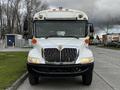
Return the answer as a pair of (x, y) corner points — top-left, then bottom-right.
(27, 8), (94, 85)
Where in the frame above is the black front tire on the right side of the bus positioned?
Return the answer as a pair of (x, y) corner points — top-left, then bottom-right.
(82, 71), (93, 85)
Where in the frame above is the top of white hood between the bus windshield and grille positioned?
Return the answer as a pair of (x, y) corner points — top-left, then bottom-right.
(36, 38), (85, 48)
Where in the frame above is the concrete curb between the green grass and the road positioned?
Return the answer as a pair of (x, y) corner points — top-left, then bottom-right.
(5, 72), (28, 90)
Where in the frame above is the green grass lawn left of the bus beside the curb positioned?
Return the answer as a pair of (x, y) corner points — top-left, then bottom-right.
(0, 52), (27, 90)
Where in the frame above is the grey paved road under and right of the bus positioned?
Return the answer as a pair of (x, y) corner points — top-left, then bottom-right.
(18, 46), (120, 90)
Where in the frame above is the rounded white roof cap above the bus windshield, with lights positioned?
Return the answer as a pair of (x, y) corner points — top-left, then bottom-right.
(33, 8), (88, 20)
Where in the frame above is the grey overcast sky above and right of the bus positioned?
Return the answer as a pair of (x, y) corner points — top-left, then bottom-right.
(45, 0), (120, 33)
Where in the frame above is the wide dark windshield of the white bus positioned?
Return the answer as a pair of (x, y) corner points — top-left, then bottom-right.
(35, 21), (86, 37)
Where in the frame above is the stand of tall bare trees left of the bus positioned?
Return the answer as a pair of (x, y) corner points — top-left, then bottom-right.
(0, 0), (47, 37)
